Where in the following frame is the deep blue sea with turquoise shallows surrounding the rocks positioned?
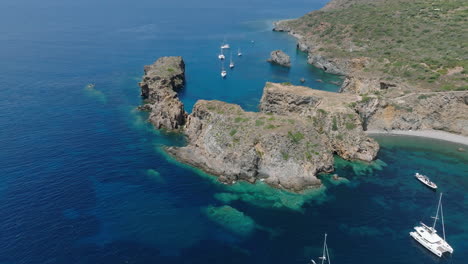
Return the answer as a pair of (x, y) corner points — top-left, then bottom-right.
(0, 0), (468, 264)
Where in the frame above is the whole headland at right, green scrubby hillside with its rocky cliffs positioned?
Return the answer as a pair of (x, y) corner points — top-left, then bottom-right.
(273, 0), (468, 136)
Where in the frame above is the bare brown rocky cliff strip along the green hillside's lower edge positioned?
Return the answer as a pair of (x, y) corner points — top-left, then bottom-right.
(273, 13), (468, 137)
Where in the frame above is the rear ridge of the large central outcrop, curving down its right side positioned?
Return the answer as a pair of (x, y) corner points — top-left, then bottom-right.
(260, 83), (379, 161)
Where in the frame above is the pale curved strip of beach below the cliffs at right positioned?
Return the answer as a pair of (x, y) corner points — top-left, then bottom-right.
(366, 130), (468, 146)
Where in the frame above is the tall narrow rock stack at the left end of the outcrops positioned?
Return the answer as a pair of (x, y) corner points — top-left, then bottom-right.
(139, 57), (187, 130)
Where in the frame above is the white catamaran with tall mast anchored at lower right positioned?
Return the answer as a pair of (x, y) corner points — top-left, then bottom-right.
(410, 193), (453, 257)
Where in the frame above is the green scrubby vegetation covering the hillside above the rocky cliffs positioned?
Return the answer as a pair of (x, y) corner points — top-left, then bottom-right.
(288, 0), (468, 90)
